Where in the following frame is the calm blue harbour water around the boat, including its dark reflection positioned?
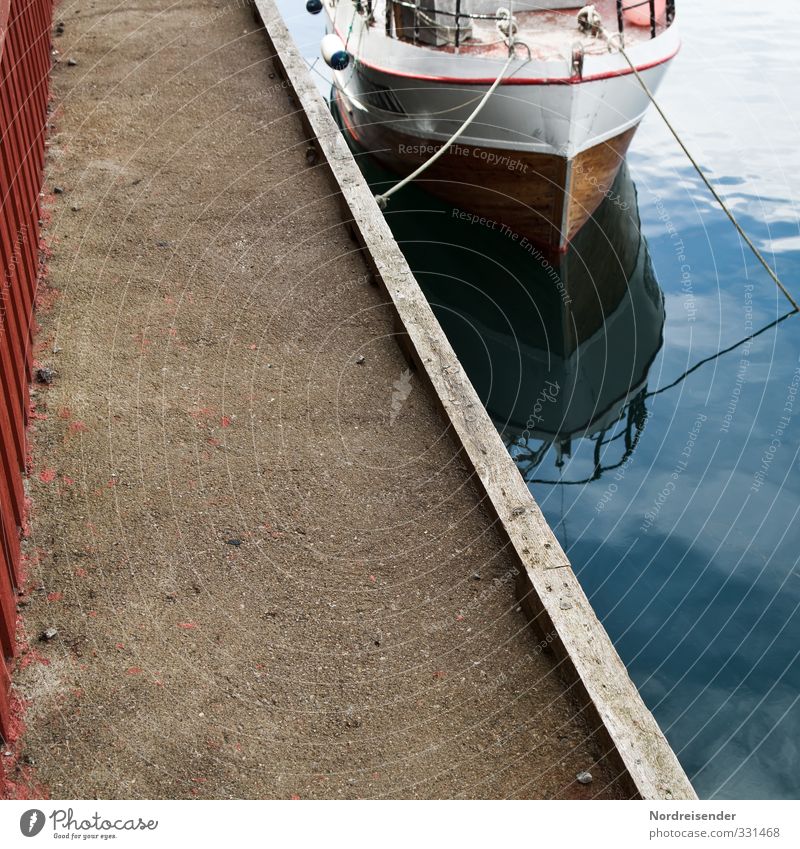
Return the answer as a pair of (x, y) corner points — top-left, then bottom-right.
(282, 0), (800, 798)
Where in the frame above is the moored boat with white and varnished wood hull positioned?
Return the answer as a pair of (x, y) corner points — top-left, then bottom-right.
(322, 0), (679, 251)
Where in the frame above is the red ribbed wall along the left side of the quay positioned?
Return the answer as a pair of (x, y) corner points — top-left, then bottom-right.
(0, 0), (52, 736)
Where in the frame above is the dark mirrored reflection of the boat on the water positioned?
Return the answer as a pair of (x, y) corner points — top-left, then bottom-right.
(368, 155), (665, 483)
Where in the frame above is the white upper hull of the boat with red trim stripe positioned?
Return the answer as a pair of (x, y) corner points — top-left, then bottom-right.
(325, 0), (680, 159)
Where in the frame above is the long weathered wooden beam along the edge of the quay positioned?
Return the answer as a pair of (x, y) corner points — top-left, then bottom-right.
(255, 0), (697, 799)
